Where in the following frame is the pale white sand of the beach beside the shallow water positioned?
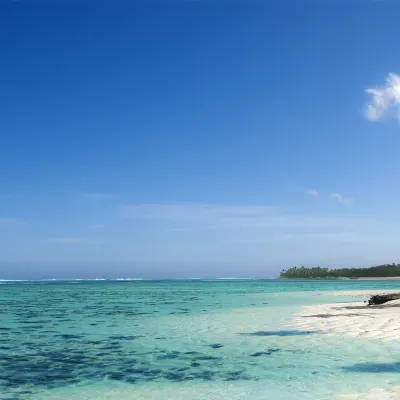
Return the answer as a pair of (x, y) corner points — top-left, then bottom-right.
(292, 290), (400, 400)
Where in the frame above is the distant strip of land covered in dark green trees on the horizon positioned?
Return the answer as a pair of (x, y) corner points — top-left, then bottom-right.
(280, 264), (400, 279)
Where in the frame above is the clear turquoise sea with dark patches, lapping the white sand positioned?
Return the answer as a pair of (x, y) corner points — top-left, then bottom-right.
(0, 280), (400, 400)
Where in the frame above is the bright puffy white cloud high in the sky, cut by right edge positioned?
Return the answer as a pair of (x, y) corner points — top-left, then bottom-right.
(364, 73), (400, 121)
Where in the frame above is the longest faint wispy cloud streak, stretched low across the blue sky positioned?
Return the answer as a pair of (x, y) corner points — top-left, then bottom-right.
(121, 203), (360, 230)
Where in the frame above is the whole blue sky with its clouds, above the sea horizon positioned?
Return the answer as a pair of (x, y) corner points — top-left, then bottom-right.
(0, 0), (400, 279)
